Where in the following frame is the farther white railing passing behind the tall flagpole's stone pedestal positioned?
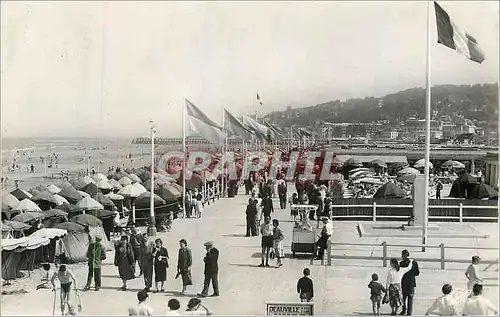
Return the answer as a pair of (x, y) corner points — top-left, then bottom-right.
(332, 202), (498, 222)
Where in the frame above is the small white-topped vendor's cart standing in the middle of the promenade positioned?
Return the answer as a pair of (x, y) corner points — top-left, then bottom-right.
(291, 205), (318, 257)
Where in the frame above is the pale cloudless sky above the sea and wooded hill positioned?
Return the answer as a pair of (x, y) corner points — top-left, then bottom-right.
(1, 1), (499, 137)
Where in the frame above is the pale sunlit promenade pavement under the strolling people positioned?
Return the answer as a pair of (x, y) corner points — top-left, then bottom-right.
(1, 195), (498, 315)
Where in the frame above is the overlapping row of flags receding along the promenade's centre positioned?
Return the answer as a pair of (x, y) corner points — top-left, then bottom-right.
(186, 99), (312, 144)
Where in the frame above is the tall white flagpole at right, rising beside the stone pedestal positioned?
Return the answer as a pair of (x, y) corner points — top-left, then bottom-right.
(422, 1), (431, 252)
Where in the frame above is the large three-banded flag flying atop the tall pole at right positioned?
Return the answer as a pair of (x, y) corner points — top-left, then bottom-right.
(434, 1), (485, 64)
